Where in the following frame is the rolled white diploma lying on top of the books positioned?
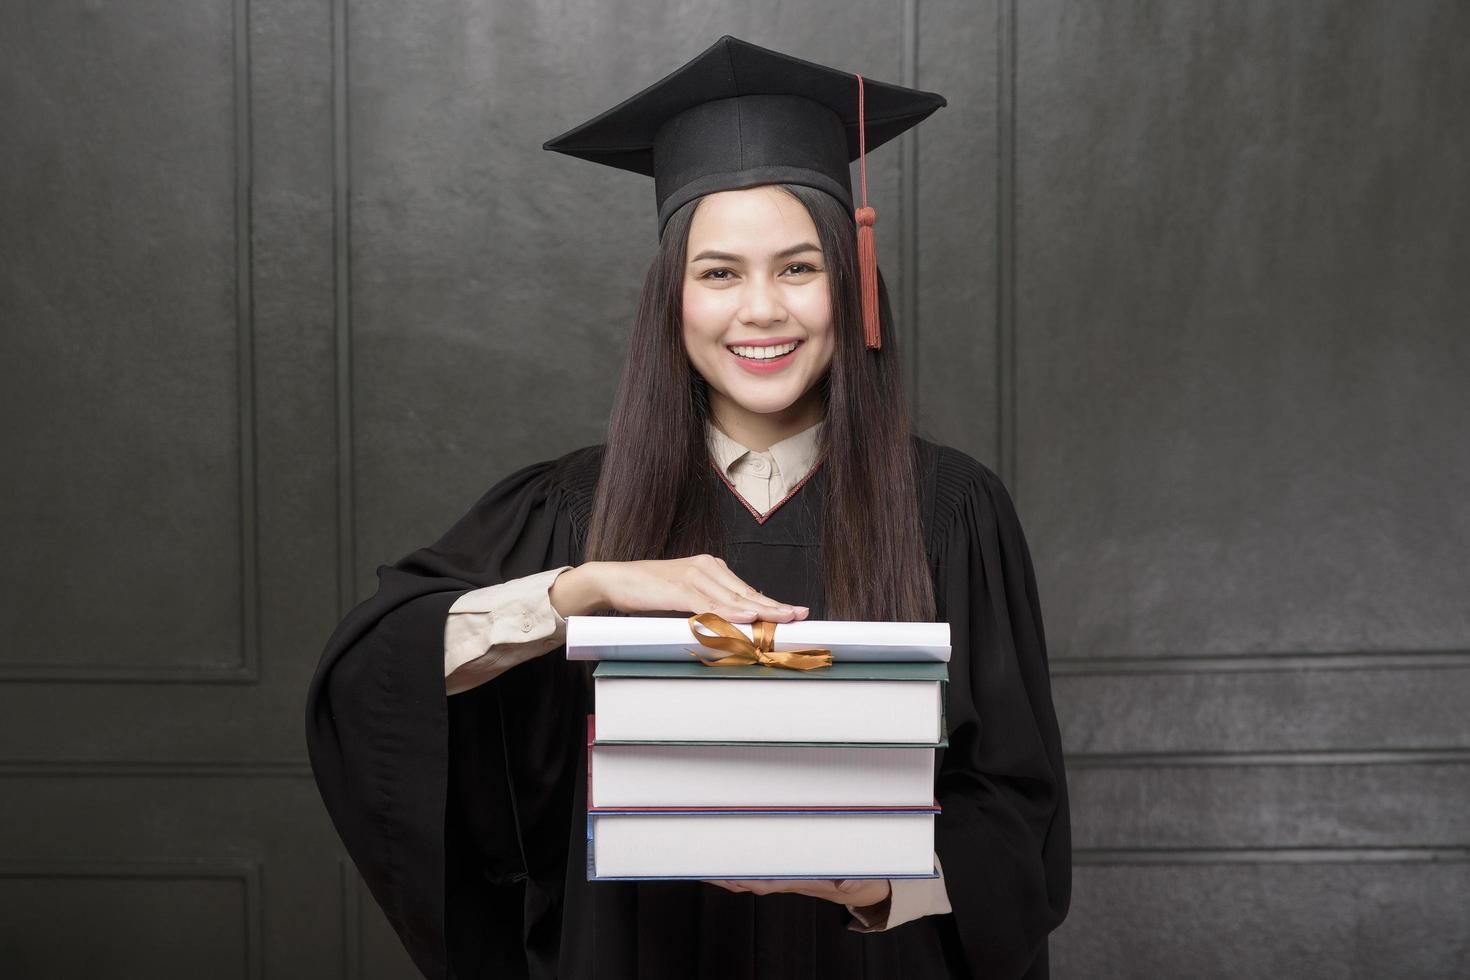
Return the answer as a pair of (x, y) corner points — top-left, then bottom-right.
(566, 616), (950, 663)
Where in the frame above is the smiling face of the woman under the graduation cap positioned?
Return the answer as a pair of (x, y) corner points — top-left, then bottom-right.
(684, 187), (833, 423)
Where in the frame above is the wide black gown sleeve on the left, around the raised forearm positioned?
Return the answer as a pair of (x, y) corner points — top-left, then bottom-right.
(306, 461), (575, 977)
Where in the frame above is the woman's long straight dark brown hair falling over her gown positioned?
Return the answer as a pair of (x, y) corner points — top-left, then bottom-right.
(587, 184), (935, 621)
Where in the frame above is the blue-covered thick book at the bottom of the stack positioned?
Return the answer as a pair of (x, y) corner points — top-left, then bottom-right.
(587, 807), (936, 880)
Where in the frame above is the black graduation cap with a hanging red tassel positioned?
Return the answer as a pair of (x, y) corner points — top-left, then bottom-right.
(542, 35), (947, 348)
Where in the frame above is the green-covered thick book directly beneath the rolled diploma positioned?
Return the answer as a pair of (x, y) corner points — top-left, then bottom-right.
(592, 661), (948, 746)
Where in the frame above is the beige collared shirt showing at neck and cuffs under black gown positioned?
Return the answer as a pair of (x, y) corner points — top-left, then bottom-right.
(444, 422), (950, 932)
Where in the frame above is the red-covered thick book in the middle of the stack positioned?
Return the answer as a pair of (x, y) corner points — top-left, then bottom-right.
(588, 742), (935, 807)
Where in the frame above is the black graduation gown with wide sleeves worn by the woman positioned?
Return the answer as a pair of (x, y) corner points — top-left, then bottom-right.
(307, 439), (1072, 980)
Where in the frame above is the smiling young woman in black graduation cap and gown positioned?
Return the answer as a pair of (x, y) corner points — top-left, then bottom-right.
(307, 38), (1070, 979)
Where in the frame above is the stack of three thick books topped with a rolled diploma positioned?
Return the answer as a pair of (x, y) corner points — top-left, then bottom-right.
(566, 616), (950, 880)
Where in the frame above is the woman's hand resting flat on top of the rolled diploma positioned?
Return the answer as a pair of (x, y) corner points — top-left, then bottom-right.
(550, 554), (810, 623)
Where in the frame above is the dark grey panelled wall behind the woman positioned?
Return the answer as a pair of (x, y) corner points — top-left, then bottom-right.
(0, 0), (1470, 979)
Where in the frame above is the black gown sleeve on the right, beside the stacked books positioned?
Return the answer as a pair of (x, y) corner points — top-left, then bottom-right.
(935, 450), (1072, 977)
